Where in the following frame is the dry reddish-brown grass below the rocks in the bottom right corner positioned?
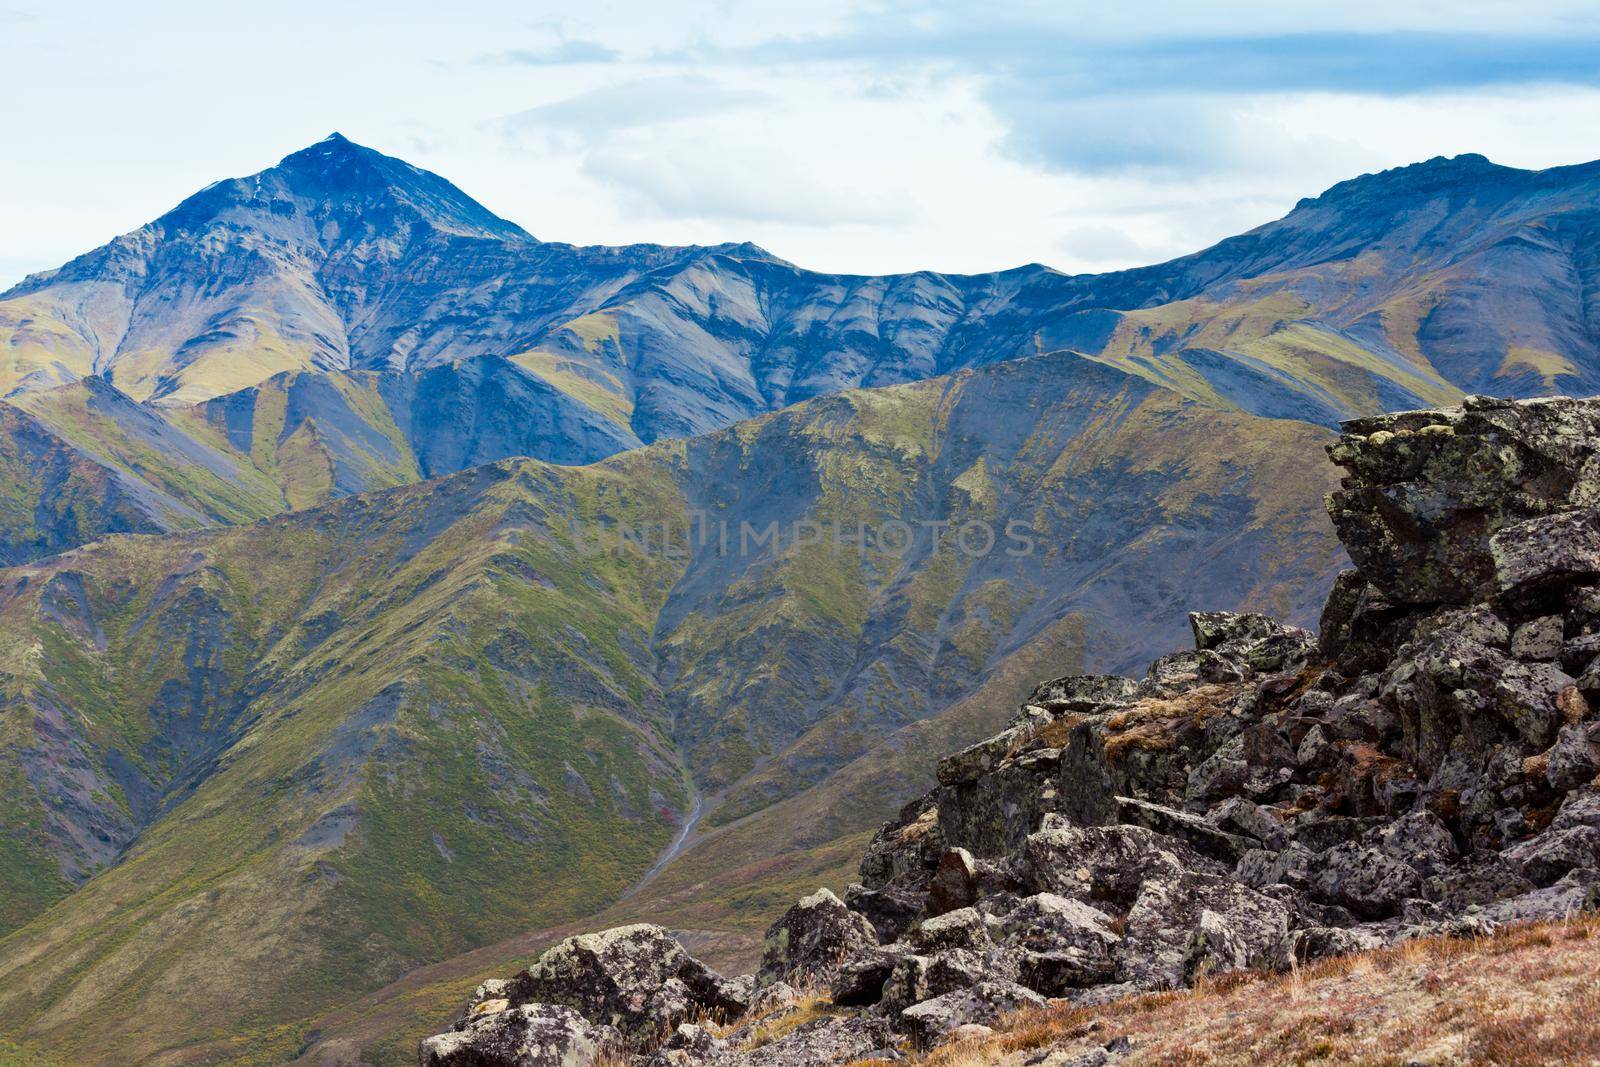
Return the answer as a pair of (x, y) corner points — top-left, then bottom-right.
(912, 917), (1600, 1067)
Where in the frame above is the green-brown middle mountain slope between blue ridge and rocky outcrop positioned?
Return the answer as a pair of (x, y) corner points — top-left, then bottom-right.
(0, 357), (1338, 1061)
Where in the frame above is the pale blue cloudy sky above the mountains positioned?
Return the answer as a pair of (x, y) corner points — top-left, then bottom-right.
(0, 0), (1600, 286)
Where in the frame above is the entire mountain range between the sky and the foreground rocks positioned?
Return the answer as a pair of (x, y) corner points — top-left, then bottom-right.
(0, 134), (1600, 1062)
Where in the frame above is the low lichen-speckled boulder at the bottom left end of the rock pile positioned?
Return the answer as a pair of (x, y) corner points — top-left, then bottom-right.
(418, 1005), (622, 1067)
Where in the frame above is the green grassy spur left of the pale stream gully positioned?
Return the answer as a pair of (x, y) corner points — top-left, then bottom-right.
(0, 464), (686, 1059)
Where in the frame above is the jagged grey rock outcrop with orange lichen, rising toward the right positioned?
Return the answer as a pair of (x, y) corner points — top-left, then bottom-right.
(421, 397), (1600, 1067)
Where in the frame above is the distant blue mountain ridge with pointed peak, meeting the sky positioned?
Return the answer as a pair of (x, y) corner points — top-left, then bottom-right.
(0, 134), (1600, 558)
